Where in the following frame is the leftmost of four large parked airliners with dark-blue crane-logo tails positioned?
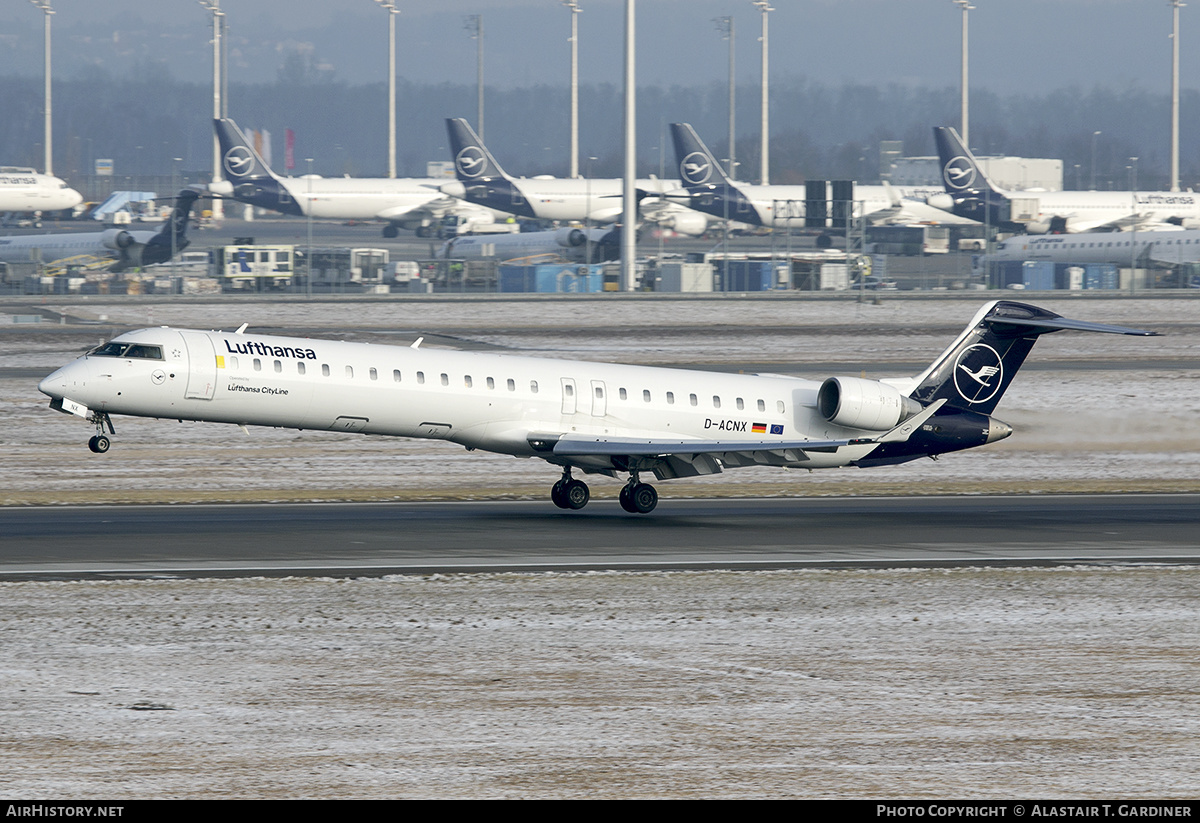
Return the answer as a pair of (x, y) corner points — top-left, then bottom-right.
(209, 119), (508, 238)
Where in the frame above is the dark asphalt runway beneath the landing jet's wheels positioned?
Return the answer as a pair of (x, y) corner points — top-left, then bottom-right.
(0, 494), (1200, 579)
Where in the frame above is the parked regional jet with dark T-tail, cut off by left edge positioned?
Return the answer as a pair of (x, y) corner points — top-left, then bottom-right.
(0, 188), (199, 271)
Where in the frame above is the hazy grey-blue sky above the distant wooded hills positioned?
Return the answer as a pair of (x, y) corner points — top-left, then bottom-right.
(0, 0), (1185, 94)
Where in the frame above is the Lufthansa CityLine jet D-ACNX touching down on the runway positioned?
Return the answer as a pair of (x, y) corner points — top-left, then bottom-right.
(38, 300), (1154, 513)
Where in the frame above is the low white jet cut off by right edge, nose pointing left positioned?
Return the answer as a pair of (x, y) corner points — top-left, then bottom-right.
(979, 229), (1200, 266)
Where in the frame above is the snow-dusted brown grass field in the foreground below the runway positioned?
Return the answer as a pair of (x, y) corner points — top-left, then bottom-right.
(0, 567), (1200, 800)
